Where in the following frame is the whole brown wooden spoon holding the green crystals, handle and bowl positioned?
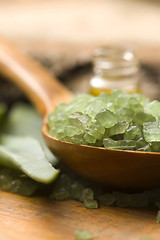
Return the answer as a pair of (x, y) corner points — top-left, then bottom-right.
(0, 39), (160, 190)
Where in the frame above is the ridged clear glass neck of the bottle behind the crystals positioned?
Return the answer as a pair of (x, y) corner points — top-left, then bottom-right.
(93, 48), (139, 80)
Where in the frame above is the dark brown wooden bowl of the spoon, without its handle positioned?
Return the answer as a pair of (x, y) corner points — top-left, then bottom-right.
(42, 124), (160, 190)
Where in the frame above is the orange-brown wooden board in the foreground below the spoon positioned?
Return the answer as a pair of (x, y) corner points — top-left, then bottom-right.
(0, 192), (160, 240)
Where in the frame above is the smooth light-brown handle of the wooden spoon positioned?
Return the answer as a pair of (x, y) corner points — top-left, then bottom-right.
(0, 38), (73, 116)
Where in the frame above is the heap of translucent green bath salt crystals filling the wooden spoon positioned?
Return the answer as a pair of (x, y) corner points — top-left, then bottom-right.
(48, 90), (160, 152)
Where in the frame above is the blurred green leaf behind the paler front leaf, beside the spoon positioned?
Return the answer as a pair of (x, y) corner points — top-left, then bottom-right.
(4, 103), (57, 166)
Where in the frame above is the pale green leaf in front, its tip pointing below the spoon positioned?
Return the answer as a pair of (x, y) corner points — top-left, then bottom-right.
(0, 135), (59, 183)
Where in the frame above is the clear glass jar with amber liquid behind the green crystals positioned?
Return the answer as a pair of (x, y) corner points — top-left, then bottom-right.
(90, 47), (140, 95)
